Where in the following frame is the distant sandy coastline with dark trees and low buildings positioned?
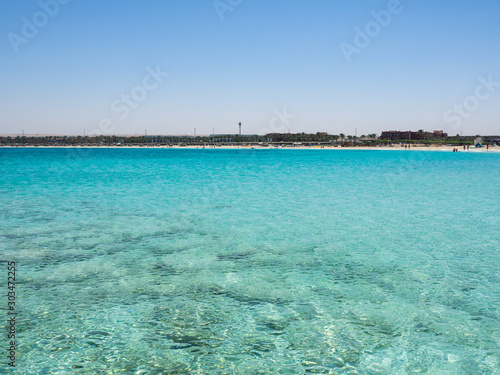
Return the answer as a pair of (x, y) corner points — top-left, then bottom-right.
(0, 130), (500, 151)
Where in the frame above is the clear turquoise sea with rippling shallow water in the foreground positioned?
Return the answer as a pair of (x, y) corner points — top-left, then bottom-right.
(0, 149), (500, 375)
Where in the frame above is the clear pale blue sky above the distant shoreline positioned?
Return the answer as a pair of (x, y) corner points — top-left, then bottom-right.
(0, 0), (500, 136)
